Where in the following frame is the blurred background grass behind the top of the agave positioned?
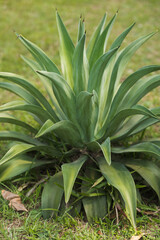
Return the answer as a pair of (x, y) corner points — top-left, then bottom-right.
(0, 0), (160, 104)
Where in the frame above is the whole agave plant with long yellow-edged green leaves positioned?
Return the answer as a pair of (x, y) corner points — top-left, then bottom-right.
(0, 12), (160, 227)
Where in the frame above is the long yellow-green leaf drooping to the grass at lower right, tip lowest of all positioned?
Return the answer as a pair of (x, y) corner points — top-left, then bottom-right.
(99, 158), (136, 228)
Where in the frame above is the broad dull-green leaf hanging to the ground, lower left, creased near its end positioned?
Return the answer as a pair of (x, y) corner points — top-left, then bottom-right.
(41, 172), (64, 219)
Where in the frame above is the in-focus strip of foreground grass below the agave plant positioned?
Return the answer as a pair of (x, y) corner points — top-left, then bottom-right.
(0, 173), (160, 240)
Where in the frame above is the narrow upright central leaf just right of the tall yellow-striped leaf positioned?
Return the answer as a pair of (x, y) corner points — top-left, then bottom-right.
(73, 35), (87, 95)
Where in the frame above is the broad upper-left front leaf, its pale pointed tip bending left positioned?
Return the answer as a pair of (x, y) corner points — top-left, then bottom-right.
(38, 71), (77, 122)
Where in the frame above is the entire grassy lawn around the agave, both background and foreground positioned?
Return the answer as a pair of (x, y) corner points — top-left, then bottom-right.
(0, 0), (160, 240)
